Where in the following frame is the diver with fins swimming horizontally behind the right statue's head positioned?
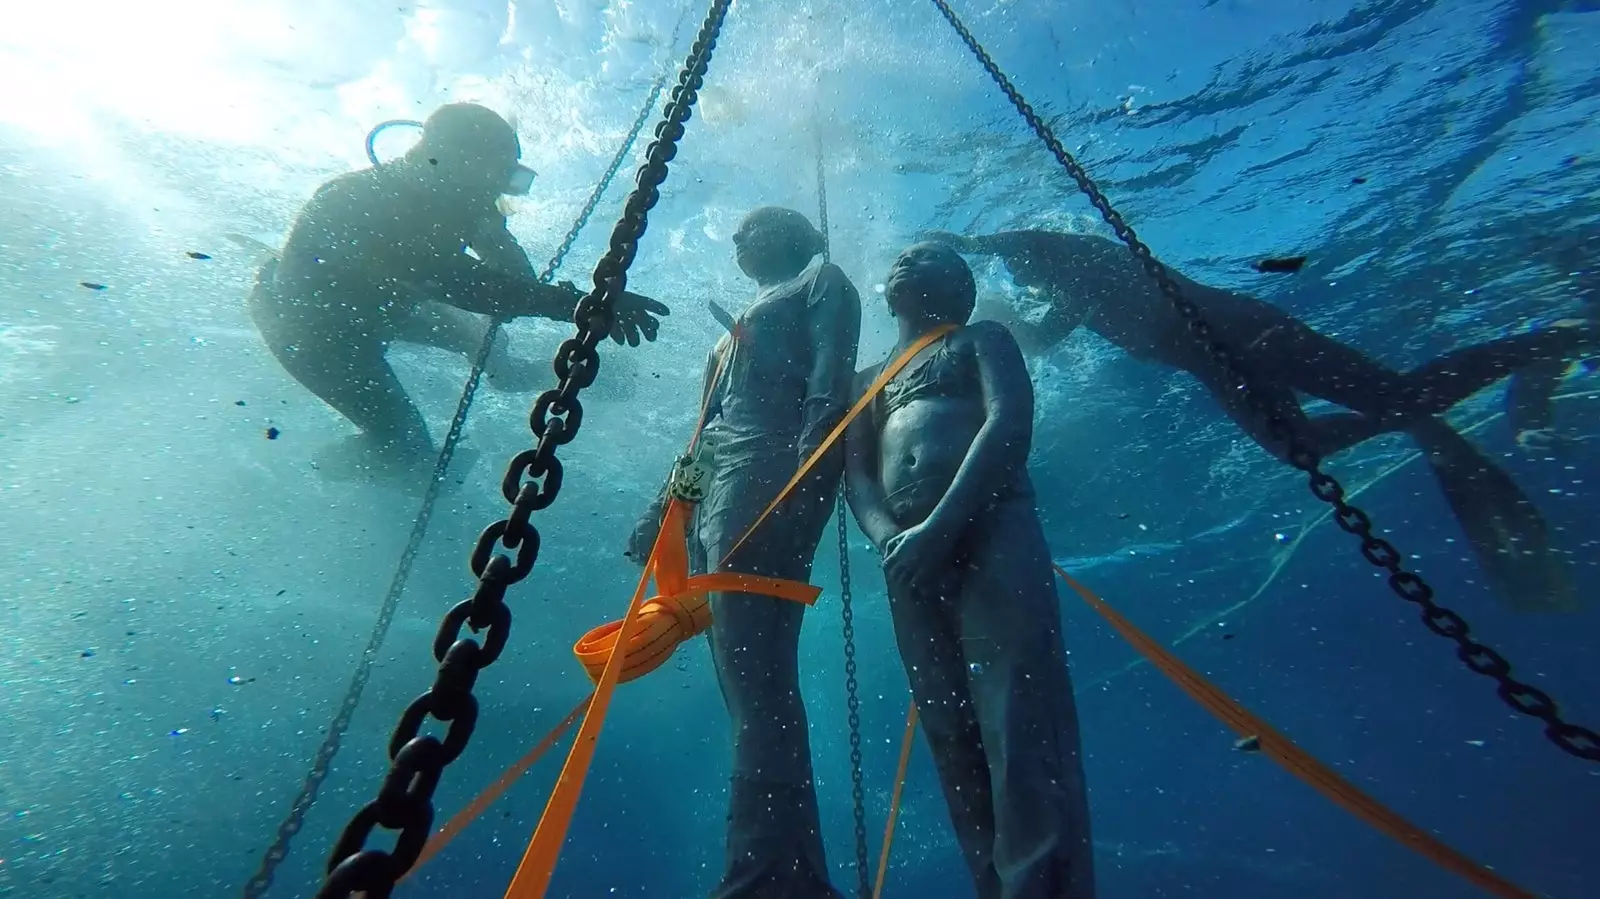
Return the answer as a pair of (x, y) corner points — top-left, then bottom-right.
(922, 230), (1600, 611)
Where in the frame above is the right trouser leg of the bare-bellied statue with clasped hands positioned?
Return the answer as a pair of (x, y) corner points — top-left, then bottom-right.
(957, 497), (1094, 899)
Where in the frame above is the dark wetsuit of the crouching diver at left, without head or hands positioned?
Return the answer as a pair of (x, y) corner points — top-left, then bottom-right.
(259, 163), (578, 454)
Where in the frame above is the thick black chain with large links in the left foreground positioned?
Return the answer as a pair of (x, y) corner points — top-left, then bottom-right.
(304, 0), (731, 899)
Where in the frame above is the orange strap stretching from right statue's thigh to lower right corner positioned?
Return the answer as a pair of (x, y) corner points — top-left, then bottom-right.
(1054, 566), (1534, 899)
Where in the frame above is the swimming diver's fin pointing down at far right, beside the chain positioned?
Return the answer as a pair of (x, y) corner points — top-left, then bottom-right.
(1408, 418), (1579, 611)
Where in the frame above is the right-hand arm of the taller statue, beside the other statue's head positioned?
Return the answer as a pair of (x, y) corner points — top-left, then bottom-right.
(797, 264), (861, 460)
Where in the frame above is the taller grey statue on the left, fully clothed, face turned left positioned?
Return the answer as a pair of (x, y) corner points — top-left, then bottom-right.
(626, 206), (861, 899)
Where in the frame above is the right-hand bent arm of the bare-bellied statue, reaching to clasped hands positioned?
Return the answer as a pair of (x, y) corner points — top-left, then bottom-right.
(923, 322), (1034, 534)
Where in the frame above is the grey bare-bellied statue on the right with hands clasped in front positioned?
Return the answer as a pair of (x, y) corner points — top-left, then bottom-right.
(845, 243), (1094, 899)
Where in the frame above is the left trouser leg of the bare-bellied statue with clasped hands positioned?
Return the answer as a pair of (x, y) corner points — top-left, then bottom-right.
(890, 571), (1000, 899)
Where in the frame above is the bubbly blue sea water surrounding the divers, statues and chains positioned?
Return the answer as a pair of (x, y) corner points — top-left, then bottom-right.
(0, 0), (1600, 899)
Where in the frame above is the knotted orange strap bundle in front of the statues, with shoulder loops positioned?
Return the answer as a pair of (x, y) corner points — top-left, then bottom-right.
(492, 325), (955, 899)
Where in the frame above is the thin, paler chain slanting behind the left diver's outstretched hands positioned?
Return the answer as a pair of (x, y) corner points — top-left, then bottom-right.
(245, 57), (667, 899)
